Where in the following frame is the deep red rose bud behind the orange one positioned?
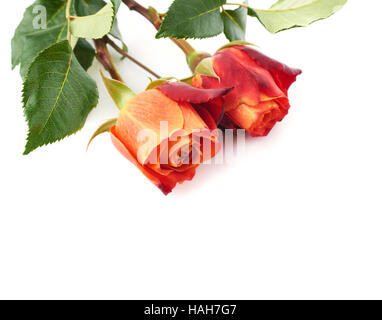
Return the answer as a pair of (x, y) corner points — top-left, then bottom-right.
(192, 45), (301, 137)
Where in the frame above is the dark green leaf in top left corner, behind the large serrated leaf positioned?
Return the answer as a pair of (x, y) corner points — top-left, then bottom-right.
(12, 0), (67, 78)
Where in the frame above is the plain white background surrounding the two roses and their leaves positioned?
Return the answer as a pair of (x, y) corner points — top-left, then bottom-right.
(0, 0), (382, 299)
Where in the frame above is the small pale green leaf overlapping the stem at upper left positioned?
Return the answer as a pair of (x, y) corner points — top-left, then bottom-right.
(70, 3), (114, 39)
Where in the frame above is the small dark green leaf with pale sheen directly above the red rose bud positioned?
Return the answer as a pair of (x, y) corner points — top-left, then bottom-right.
(221, 3), (248, 41)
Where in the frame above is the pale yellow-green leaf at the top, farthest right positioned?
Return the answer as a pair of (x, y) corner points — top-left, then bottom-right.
(248, 0), (347, 33)
